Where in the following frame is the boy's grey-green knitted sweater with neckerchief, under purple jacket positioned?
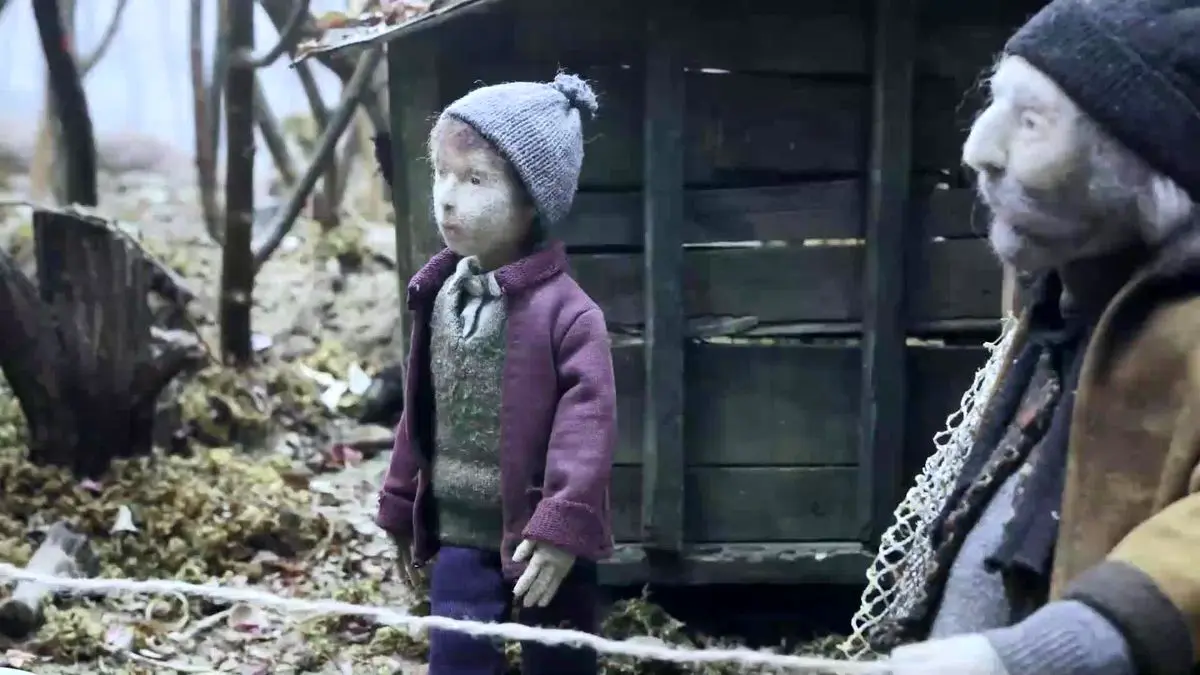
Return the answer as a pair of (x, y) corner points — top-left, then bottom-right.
(430, 257), (506, 550)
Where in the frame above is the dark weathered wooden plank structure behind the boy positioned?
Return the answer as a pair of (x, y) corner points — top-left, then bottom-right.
(312, 0), (1051, 584)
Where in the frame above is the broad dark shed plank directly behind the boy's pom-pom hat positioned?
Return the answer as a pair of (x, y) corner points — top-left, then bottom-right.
(443, 60), (869, 190)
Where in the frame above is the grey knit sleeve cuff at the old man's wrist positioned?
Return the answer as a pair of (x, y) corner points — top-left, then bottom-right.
(984, 601), (1136, 675)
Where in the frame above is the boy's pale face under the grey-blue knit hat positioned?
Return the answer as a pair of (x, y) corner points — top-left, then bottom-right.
(430, 118), (534, 259)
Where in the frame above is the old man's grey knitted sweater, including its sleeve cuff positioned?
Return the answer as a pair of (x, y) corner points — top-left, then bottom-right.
(930, 357), (1136, 675)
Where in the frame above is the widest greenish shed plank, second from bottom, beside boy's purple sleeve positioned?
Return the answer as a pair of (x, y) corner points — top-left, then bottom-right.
(613, 342), (860, 466)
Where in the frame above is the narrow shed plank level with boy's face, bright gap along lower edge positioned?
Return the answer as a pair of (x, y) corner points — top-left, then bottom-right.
(564, 179), (988, 249)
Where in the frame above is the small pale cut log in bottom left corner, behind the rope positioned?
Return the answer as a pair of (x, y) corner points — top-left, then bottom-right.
(0, 521), (100, 640)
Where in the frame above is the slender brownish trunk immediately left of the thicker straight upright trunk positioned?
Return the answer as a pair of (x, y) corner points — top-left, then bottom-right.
(188, 0), (223, 241)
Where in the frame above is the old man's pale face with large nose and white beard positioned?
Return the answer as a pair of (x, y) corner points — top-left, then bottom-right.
(962, 56), (1174, 271)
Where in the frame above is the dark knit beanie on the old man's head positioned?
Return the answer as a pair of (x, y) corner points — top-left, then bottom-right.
(1004, 0), (1200, 201)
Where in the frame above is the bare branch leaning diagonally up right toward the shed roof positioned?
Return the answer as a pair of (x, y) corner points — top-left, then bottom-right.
(254, 47), (383, 273)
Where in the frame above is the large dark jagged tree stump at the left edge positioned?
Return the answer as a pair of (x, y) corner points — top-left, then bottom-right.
(0, 209), (205, 478)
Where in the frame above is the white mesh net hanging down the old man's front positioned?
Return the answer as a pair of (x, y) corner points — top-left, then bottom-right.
(839, 317), (1016, 659)
